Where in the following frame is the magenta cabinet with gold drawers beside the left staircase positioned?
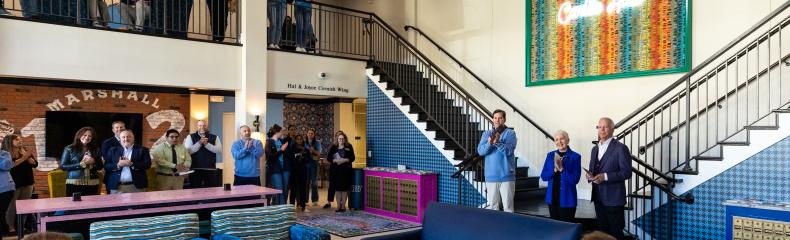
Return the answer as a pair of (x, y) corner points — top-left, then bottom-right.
(365, 167), (438, 223)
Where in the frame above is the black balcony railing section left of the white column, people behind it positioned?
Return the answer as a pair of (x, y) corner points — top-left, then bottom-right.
(0, 0), (241, 43)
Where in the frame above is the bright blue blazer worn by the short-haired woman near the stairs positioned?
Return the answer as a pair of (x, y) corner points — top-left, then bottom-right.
(540, 148), (582, 208)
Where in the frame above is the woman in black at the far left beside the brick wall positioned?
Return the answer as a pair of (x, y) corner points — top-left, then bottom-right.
(3, 134), (38, 232)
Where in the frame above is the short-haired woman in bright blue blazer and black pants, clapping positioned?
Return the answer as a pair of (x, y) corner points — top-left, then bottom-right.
(540, 130), (582, 222)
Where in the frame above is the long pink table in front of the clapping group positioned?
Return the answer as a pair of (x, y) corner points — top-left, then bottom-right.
(16, 185), (282, 239)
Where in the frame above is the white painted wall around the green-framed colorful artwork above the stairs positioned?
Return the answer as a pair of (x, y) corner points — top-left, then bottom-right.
(346, 0), (784, 198)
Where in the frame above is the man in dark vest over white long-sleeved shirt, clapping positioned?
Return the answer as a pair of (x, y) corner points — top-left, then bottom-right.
(184, 120), (222, 188)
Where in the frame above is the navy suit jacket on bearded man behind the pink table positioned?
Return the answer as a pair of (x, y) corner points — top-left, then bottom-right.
(104, 145), (151, 190)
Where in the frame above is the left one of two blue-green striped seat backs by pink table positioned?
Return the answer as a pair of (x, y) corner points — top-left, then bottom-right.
(90, 213), (198, 240)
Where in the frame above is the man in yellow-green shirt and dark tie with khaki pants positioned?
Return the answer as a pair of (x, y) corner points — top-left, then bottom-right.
(151, 129), (192, 191)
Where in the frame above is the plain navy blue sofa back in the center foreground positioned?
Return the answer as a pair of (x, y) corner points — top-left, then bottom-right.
(363, 203), (582, 240)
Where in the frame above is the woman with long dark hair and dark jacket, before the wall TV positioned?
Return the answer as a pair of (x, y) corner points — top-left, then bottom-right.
(60, 127), (104, 196)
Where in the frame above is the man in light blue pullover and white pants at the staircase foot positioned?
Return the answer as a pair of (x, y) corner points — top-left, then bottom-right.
(477, 109), (518, 213)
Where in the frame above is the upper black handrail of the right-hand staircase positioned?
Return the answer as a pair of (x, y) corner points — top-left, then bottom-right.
(614, 1), (790, 129)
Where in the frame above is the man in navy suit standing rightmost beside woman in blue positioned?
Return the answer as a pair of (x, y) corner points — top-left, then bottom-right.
(586, 118), (631, 239)
